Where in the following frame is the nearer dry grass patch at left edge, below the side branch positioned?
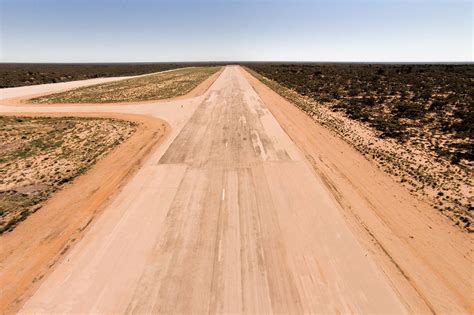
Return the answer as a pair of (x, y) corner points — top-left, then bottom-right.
(0, 116), (136, 234)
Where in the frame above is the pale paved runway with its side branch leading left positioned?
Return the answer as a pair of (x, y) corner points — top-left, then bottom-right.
(0, 67), (472, 313)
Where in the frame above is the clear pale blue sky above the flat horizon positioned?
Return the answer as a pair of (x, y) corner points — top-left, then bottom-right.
(0, 0), (474, 62)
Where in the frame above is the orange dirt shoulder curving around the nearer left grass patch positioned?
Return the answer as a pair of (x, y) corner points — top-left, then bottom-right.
(0, 113), (170, 313)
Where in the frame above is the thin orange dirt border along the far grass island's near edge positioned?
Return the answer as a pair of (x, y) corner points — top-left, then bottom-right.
(1, 67), (224, 106)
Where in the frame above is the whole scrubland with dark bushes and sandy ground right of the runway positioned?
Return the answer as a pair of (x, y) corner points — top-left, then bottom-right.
(246, 65), (474, 232)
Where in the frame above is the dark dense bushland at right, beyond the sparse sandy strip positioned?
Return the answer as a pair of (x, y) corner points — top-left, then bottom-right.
(249, 63), (474, 163)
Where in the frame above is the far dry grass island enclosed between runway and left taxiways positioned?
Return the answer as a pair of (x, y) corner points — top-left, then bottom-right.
(31, 67), (220, 103)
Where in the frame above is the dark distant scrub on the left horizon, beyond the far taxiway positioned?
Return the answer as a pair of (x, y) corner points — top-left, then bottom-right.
(0, 63), (226, 88)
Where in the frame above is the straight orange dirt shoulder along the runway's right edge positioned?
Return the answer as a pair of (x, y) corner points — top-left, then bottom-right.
(242, 69), (474, 313)
